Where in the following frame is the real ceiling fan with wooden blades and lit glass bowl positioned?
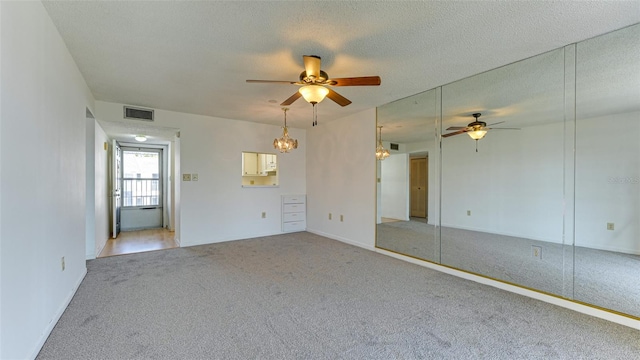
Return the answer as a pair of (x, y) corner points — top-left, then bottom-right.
(247, 55), (380, 126)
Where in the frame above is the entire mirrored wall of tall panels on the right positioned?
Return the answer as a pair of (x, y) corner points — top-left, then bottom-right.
(376, 25), (640, 317)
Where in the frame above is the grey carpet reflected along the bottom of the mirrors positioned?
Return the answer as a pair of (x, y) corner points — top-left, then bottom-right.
(377, 221), (640, 316)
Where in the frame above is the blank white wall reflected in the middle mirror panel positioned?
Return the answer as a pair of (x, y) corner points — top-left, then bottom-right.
(442, 123), (564, 243)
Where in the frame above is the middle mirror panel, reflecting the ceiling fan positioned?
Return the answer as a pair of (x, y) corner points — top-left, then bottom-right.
(441, 49), (571, 295)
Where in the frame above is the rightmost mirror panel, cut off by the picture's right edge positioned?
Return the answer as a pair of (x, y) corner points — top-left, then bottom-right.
(575, 25), (640, 317)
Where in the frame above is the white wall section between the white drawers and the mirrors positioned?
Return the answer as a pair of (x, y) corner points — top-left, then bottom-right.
(304, 109), (376, 249)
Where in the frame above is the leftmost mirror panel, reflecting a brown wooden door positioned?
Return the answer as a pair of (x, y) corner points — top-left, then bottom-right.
(376, 90), (439, 261)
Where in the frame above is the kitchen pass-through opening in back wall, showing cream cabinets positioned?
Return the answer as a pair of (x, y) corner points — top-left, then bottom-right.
(242, 152), (278, 187)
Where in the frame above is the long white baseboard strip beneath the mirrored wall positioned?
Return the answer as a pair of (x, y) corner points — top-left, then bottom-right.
(374, 248), (640, 330)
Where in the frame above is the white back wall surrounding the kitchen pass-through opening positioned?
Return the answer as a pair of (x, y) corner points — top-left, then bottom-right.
(95, 101), (306, 246)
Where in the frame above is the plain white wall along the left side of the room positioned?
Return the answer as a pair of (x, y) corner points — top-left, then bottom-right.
(0, 1), (95, 359)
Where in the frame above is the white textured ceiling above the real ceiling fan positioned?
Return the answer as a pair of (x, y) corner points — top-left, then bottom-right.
(44, 1), (640, 139)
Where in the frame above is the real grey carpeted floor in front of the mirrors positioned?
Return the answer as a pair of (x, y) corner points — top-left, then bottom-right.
(38, 232), (640, 359)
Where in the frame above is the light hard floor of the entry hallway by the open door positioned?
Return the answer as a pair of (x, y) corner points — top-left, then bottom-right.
(98, 228), (178, 258)
